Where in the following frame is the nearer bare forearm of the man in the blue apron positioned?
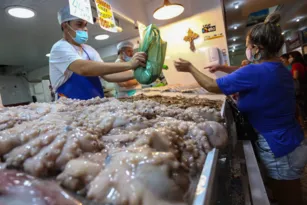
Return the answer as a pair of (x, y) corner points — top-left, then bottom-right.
(68, 60), (131, 76)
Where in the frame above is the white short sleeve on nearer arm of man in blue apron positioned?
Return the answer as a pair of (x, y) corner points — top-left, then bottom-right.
(49, 41), (81, 75)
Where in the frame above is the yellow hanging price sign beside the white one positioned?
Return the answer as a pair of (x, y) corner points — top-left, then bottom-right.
(95, 0), (117, 32)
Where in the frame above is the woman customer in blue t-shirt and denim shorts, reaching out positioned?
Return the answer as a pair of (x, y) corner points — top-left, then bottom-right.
(175, 14), (307, 205)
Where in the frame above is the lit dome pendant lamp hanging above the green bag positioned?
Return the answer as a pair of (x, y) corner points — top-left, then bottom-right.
(153, 0), (184, 20)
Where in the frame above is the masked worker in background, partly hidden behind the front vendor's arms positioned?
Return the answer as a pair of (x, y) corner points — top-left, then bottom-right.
(115, 41), (142, 98)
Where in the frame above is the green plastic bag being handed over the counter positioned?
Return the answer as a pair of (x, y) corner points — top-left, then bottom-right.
(134, 24), (167, 84)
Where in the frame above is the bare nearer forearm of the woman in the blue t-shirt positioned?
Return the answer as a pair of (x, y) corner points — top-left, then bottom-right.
(191, 67), (222, 93)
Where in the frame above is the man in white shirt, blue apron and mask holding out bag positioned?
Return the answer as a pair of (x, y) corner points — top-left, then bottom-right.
(49, 6), (146, 100)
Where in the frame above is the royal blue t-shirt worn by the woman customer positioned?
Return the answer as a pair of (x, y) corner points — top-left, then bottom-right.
(216, 62), (304, 157)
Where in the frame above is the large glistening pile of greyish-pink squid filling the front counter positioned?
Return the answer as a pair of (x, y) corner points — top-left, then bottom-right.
(0, 98), (227, 205)
